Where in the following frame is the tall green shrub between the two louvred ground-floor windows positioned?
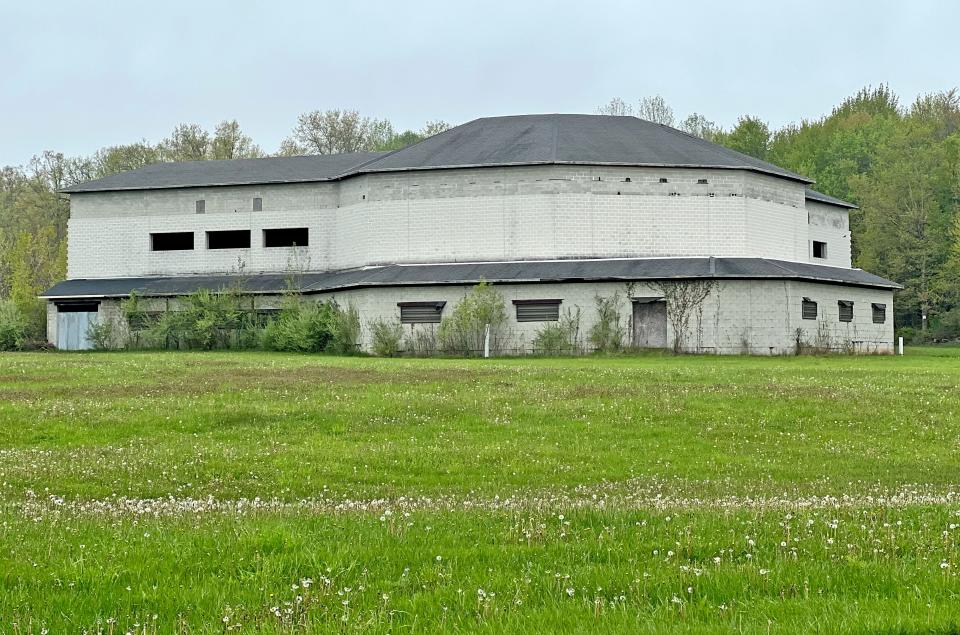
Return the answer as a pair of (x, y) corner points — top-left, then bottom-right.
(438, 281), (507, 355)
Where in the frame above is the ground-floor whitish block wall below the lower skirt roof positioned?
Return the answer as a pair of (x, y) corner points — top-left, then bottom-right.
(65, 280), (893, 355)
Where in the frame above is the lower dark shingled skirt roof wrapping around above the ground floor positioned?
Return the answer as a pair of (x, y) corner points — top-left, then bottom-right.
(41, 258), (900, 298)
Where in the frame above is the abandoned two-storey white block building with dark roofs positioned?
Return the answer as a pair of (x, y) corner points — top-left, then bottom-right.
(44, 115), (899, 354)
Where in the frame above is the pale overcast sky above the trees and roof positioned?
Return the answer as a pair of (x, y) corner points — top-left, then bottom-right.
(0, 0), (960, 165)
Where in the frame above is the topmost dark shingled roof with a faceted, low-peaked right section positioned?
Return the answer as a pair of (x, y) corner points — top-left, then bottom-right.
(63, 114), (812, 193)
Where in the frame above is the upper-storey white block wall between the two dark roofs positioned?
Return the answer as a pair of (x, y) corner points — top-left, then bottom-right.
(68, 166), (849, 278)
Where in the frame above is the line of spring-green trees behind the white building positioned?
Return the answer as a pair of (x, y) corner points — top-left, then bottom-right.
(0, 85), (960, 340)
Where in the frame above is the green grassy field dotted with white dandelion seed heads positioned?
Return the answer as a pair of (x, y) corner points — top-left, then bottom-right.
(0, 349), (960, 634)
